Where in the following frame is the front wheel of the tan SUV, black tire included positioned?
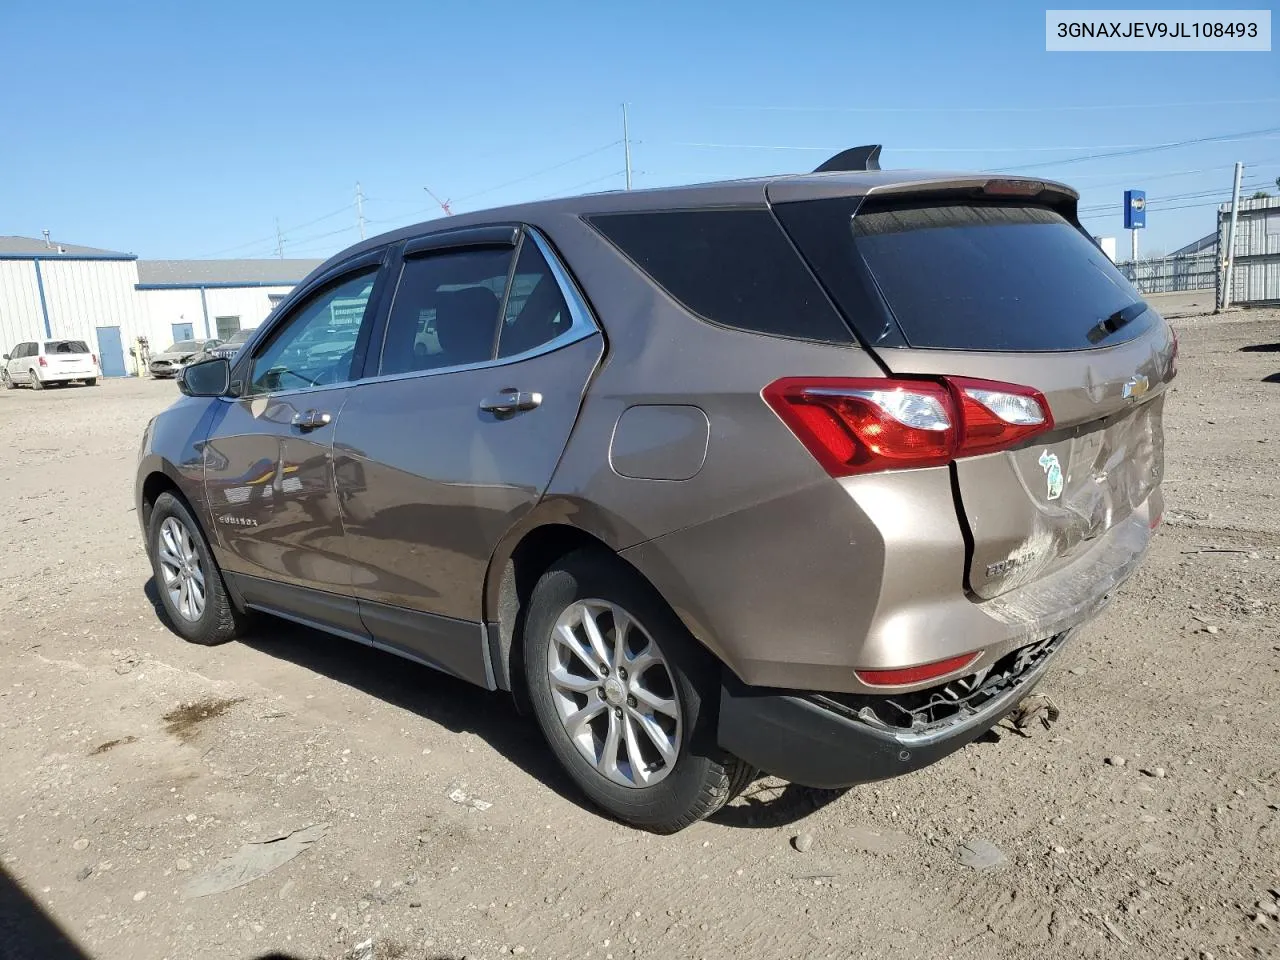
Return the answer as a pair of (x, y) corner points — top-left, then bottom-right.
(147, 493), (244, 646)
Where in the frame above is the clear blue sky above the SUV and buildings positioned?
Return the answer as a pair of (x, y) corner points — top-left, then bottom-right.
(0, 0), (1280, 257)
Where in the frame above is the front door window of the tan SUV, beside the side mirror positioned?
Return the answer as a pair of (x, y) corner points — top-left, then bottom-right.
(246, 266), (378, 396)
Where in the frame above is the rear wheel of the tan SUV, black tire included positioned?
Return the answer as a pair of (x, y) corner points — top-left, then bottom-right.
(524, 550), (755, 833)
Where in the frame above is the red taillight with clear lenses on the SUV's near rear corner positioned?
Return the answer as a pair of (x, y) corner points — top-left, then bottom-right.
(762, 376), (1053, 476)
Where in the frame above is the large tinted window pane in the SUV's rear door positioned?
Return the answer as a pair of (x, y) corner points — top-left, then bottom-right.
(379, 244), (512, 375)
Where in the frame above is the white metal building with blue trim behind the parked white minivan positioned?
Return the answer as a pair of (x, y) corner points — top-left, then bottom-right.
(0, 237), (320, 376)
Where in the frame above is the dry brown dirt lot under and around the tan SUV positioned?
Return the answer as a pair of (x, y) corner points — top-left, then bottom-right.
(0, 312), (1280, 960)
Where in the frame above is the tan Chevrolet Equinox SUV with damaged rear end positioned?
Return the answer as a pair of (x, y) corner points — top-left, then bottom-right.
(137, 152), (1176, 831)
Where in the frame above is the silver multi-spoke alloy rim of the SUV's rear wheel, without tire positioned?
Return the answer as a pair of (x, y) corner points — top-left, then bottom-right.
(547, 600), (682, 787)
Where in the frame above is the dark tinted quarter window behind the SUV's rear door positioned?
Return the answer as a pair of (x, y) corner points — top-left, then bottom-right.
(589, 207), (854, 343)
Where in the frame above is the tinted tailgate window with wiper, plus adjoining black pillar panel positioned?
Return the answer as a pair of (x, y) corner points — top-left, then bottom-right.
(778, 201), (1157, 351)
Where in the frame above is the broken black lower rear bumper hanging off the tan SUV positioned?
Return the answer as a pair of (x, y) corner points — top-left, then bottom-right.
(719, 630), (1075, 787)
